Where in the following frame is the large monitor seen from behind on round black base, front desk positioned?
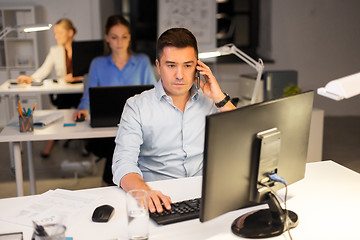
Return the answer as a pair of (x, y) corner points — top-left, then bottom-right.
(200, 91), (314, 238)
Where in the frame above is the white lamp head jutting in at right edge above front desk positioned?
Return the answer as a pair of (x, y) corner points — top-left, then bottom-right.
(317, 72), (360, 101)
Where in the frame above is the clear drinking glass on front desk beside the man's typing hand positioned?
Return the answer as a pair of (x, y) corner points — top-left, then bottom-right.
(126, 190), (149, 240)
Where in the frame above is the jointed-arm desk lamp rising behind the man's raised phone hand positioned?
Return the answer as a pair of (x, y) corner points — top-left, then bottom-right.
(199, 43), (264, 104)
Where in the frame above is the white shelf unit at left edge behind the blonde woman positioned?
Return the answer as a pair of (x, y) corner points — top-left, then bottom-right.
(0, 5), (41, 126)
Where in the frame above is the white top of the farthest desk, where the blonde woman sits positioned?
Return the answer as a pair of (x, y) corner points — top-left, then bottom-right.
(0, 79), (84, 96)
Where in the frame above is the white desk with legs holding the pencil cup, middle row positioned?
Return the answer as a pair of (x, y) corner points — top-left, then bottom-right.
(0, 109), (117, 196)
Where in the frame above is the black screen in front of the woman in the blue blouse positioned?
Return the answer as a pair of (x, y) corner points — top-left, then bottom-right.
(89, 85), (154, 128)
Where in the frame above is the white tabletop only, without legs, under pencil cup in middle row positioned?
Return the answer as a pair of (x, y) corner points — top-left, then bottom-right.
(0, 109), (117, 142)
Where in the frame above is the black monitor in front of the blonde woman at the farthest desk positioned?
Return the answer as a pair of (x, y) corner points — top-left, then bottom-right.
(72, 40), (104, 77)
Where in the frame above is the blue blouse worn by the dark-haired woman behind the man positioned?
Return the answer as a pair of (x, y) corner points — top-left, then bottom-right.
(78, 54), (156, 110)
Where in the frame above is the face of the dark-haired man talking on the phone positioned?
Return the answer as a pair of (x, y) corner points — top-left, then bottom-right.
(156, 47), (197, 97)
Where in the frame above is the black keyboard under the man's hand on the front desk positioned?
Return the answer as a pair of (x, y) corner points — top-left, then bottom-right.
(150, 198), (200, 225)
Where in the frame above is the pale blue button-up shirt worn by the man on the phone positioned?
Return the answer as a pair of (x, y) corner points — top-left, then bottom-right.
(112, 80), (218, 185)
